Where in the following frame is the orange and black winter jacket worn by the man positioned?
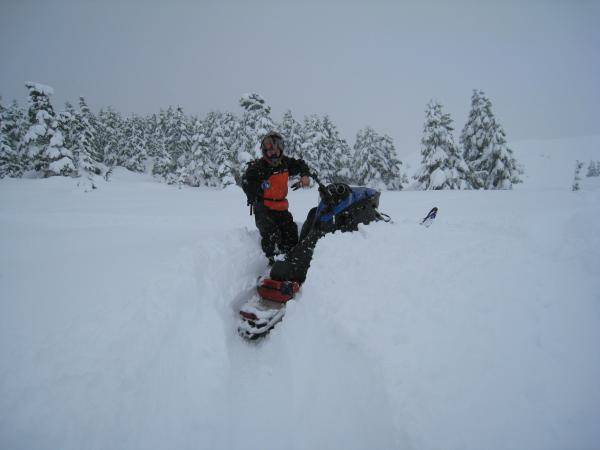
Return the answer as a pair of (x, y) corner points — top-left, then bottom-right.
(242, 155), (310, 211)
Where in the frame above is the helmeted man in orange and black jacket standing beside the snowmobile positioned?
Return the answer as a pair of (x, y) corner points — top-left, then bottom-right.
(242, 131), (310, 264)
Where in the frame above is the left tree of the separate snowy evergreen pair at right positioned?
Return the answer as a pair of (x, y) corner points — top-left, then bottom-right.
(414, 100), (469, 190)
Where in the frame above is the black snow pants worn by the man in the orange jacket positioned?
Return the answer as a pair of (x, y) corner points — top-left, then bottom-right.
(254, 203), (298, 258)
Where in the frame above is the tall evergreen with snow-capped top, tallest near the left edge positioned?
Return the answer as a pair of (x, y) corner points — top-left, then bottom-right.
(24, 82), (75, 177)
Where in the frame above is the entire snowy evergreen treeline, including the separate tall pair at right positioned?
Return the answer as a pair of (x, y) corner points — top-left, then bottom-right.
(0, 83), (521, 189)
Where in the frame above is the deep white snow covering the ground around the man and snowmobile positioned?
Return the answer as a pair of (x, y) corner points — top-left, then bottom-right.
(0, 138), (600, 450)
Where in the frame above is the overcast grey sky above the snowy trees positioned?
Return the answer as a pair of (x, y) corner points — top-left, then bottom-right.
(0, 0), (600, 155)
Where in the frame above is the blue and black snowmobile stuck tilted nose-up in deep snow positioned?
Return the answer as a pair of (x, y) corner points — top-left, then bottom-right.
(238, 174), (390, 339)
